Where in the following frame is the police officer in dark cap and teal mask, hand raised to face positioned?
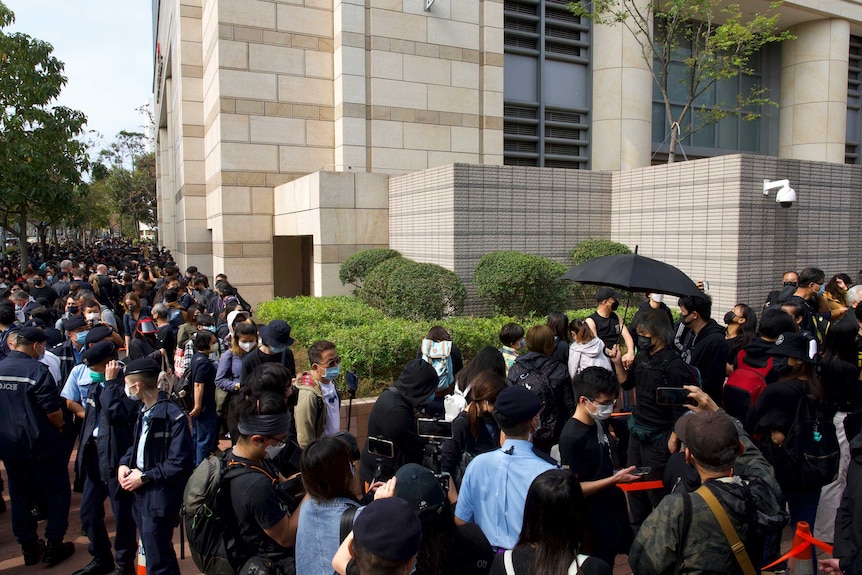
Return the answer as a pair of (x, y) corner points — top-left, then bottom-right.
(73, 342), (137, 575)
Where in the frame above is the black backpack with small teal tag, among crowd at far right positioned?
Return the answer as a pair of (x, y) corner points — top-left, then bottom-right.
(781, 395), (840, 489)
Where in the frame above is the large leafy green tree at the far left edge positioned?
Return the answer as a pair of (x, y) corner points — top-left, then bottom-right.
(0, 2), (89, 270)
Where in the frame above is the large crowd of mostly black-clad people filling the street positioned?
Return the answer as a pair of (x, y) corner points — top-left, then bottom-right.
(0, 239), (862, 575)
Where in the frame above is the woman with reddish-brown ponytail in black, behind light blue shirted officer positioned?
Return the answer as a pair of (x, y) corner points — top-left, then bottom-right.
(440, 374), (507, 491)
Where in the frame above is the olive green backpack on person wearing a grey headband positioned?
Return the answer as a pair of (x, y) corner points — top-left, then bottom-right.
(182, 451), (275, 575)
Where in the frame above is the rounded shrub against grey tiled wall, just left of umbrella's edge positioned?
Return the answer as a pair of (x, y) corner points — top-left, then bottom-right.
(473, 252), (572, 317)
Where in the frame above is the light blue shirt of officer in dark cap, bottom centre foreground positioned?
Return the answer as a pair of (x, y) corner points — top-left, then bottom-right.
(455, 439), (556, 549)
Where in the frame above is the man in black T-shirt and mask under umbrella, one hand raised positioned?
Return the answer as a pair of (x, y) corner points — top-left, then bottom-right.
(611, 311), (690, 527)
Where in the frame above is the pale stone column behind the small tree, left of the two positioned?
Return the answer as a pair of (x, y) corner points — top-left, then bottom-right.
(590, 0), (653, 171)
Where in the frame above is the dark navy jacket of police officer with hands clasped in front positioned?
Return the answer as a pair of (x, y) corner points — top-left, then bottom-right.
(120, 391), (195, 517)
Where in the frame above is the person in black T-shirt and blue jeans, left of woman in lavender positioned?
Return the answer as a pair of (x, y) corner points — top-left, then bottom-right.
(189, 330), (218, 467)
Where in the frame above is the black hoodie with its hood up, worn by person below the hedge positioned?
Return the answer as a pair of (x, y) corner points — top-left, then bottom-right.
(359, 359), (439, 483)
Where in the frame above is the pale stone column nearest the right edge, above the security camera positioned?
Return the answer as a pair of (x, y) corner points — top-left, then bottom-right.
(778, 19), (850, 163)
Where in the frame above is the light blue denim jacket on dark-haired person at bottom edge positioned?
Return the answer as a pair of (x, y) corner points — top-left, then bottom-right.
(296, 497), (359, 575)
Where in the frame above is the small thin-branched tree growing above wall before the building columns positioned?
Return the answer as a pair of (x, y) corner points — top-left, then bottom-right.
(569, 0), (793, 163)
